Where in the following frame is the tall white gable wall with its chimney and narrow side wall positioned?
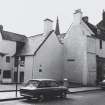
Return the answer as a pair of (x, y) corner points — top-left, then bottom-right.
(64, 10), (96, 85)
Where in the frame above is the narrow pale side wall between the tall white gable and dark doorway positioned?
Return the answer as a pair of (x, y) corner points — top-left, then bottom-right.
(87, 37), (96, 85)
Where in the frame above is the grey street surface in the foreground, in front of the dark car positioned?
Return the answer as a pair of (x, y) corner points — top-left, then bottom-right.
(0, 90), (105, 105)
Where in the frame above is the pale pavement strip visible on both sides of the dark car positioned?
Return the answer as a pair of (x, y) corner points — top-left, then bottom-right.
(0, 87), (101, 101)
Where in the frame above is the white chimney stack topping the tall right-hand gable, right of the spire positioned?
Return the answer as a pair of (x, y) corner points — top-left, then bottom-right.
(73, 9), (82, 24)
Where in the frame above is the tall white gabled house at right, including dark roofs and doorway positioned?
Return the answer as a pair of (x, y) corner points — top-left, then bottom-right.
(64, 9), (105, 85)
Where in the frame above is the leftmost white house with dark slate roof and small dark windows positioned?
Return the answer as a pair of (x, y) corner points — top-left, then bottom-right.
(0, 25), (26, 82)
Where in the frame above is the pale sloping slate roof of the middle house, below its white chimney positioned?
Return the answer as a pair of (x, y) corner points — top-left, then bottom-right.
(19, 31), (53, 55)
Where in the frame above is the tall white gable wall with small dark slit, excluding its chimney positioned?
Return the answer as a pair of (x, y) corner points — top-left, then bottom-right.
(64, 24), (87, 84)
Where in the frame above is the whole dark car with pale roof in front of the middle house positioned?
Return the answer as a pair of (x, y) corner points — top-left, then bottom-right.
(20, 79), (68, 100)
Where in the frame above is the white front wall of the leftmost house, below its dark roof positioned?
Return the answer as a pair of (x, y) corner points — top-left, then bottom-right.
(0, 33), (16, 82)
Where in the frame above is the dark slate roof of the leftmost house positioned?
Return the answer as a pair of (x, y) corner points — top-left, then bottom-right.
(1, 30), (27, 42)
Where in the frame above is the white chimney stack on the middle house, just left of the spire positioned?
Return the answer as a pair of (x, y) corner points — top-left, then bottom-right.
(44, 18), (53, 34)
